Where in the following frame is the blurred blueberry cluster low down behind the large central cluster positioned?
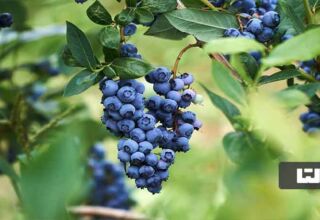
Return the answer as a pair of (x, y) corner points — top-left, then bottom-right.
(89, 144), (133, 210)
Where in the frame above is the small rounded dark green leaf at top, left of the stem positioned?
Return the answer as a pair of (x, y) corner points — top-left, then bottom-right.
(87, 0), (112, 25)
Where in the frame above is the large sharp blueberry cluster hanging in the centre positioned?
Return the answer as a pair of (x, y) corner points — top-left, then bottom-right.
(100, 67), (202, 193)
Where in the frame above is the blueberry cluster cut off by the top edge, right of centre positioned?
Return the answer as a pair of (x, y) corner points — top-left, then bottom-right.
(224, 0), (280, 61)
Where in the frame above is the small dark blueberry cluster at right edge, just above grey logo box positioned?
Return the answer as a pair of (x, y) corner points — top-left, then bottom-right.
(300, 110), (320, 133)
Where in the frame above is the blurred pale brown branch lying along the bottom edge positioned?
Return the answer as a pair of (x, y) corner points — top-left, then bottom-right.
(68, 206), (147, 220)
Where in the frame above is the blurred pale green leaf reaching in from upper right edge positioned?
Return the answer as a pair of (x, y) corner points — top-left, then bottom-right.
(262, 28), (320, 66)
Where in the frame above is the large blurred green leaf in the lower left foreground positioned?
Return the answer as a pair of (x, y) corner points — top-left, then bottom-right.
(21, 118), (105, 220)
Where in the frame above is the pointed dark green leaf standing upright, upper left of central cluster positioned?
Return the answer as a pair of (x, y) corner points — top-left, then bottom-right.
(67, 22), (98, 70)
